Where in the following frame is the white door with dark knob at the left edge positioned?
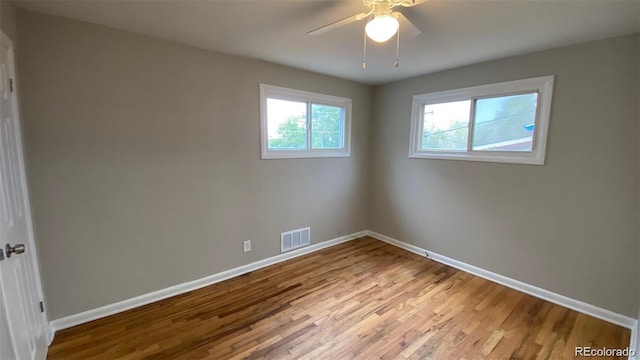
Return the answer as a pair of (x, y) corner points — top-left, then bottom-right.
(0, 33), (50, 360)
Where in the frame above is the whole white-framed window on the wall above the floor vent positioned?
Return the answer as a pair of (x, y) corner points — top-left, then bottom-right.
(260, 84), (351, 159)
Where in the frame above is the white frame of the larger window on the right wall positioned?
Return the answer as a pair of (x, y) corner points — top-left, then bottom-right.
(409, 75), (554, 165)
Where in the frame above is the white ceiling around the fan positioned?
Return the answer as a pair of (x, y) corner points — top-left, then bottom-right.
(15, 0), (640, 84)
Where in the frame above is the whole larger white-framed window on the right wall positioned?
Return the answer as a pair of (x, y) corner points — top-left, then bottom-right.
(409, 76), (554, 165)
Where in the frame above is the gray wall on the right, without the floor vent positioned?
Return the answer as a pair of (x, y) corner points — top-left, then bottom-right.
(369, 35), (639, 317)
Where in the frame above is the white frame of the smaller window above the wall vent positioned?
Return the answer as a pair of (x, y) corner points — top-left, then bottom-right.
(260, 84), (352, 159)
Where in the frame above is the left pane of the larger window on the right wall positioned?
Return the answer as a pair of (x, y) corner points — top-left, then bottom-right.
(422, 100), (471, 150)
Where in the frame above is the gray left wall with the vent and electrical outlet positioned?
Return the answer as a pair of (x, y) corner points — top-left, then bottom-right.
(18, 10), (372, 319)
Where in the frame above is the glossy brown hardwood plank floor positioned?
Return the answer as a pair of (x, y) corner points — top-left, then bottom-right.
(48, 238), (630, 360)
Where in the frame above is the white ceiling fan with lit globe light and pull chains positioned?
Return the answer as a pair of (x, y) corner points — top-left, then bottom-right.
(307, 0), (426, 69)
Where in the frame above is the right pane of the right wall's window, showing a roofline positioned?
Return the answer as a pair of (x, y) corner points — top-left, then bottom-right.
(472, 93), (538, 151)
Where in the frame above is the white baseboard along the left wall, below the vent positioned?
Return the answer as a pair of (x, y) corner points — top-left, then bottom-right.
(50, 230), (368, 332)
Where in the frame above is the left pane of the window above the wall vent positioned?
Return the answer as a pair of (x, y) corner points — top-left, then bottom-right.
(267, 98), (307, 149)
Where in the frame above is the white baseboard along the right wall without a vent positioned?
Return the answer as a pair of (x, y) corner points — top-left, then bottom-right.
(367, 231), (637, 330)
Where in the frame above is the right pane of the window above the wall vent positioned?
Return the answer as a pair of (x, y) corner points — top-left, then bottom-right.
(311, 104), (344, 149)
